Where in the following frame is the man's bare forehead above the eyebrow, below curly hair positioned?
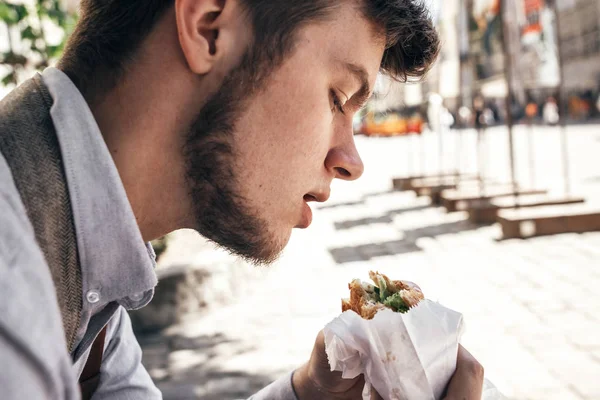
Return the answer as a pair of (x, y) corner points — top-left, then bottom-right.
(299, 1), (385, 87)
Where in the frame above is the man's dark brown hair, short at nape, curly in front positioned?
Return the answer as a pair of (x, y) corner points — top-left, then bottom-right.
(59, 0), (439, 101)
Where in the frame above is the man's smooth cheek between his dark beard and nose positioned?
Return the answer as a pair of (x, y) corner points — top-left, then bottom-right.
(235, 66), (333, 216)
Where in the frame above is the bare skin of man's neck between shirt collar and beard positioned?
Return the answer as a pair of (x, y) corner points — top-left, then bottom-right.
(83, 35), (200, 241)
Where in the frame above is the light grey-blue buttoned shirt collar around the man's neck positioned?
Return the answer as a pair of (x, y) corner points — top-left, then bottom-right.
(42, 68), (157, 309)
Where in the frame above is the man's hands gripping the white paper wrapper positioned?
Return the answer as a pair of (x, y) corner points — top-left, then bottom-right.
(293, 331), (483, 400)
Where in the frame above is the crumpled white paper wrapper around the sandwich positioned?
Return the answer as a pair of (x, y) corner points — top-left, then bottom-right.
(324, 300), (463, 400)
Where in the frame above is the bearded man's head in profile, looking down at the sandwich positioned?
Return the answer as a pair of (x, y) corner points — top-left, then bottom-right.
(60, 0), (438, 262)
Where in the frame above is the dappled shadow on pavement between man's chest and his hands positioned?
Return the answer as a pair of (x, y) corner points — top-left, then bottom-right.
(138, 333), (276, 400)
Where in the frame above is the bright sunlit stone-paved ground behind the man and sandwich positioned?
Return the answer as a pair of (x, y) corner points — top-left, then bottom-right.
(141, 126), (600, 400)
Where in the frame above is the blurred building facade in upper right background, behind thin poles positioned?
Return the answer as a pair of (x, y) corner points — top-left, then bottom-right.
(446, 0), (600, 119)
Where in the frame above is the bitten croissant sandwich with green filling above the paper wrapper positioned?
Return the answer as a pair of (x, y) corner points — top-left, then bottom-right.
(342, 271), (424, 319)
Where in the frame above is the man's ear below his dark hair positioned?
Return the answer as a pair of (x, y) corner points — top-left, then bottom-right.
(175, 0), (227, 75)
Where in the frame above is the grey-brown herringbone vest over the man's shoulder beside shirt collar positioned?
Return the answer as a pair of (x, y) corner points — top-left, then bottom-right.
(0, 75), (82, 352)
